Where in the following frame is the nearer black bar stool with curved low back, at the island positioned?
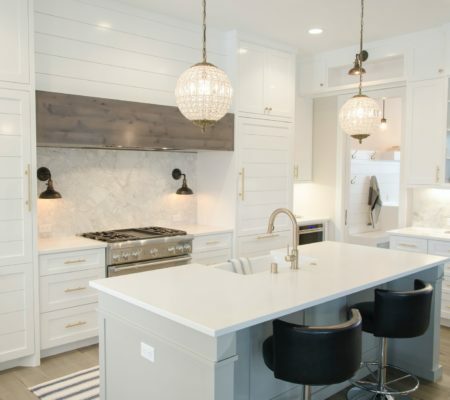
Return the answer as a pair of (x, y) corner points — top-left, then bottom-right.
(263, 310), (362, 400)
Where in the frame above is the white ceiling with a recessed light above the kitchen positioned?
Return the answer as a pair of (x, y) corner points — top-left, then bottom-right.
(118, 0), (450, 53)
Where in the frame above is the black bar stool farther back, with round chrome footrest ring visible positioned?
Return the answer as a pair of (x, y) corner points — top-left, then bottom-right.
(347, 279), (433, 400)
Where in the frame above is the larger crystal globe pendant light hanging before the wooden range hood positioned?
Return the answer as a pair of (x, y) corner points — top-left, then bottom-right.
(175, 0), (233, 132)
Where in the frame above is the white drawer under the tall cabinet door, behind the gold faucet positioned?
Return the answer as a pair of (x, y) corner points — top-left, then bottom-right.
(238, 231), (292, 257)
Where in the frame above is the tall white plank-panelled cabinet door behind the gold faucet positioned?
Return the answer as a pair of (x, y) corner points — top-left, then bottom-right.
(237, 117), (293, 235)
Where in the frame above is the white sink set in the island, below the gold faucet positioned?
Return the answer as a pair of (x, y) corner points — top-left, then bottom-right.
(212, 250), (318, 275)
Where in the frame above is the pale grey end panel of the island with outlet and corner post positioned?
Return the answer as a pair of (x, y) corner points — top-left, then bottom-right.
(99, 294), (237, 400)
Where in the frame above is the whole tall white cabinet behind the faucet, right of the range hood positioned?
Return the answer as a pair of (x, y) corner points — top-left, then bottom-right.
(236, 41), (295, 257)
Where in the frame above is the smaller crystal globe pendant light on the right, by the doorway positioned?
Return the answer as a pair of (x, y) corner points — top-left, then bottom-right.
(339, 0), (380, 143)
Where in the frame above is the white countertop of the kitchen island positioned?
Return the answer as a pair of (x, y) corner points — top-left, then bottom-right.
(91, 242), (447, 336)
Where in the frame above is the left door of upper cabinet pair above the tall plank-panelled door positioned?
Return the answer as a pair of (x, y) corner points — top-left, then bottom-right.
(238, 42), (267, 114)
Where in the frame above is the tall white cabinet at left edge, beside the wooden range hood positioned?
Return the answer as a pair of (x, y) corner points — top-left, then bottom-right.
(0, 0), (38, 369)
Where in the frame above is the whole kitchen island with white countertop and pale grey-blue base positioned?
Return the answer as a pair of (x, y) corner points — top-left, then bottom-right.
(91, 242), (446, 400)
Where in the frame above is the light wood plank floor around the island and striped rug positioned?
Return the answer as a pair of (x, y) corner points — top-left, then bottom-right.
(0, 328), (450, 400)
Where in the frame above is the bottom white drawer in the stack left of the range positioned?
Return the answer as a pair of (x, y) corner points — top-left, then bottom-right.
(41, 304), (98, 350)
